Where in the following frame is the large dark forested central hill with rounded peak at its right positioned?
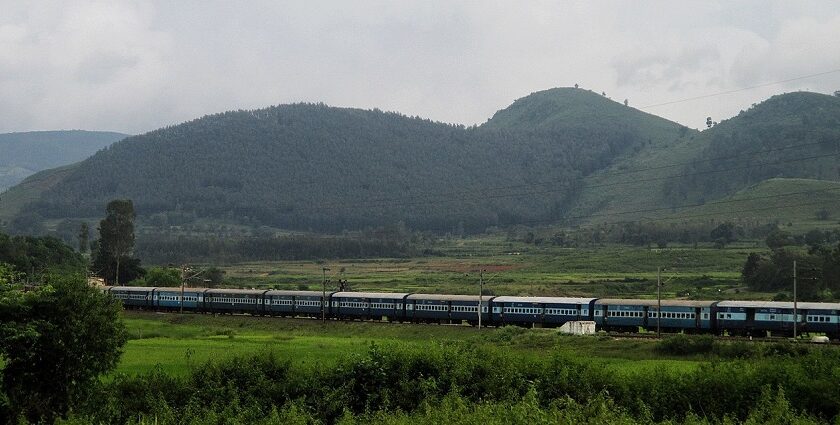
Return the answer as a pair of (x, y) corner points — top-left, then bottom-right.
(6, 89), (686, 231)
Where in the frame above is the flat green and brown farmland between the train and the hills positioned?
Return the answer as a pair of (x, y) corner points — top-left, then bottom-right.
(218, 236), (772, 299)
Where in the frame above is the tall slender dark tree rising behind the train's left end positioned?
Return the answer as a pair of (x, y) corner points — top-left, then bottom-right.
(99, 199), (134, 285)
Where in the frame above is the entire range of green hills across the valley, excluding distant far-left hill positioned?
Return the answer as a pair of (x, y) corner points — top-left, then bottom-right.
(0, 88), (840, 238)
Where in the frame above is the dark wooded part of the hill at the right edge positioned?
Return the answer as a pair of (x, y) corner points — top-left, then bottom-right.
(663, 92), (840, 203)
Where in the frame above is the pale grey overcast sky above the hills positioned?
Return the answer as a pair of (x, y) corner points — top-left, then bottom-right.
(0, 0), (840, 133)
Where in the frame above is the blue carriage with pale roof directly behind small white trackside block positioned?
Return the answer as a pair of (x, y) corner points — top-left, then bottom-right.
(493, 296), (595, 326)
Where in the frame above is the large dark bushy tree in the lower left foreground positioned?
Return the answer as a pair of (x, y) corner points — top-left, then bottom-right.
(0, 275), (127, 423)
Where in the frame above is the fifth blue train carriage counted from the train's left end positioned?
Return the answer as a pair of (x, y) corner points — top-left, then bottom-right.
(331, 292), (408, 321)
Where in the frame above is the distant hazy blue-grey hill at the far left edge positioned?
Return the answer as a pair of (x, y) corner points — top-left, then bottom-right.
(0, 130), (127, 192)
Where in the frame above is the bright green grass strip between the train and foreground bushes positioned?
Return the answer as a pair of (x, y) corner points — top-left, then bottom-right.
(116, 311), (705, 374)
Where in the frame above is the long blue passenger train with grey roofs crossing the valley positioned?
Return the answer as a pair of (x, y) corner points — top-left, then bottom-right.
(102, 286), (840, 339)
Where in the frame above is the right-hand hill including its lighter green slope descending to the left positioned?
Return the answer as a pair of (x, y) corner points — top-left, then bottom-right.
(570, 92), (840, 222)
